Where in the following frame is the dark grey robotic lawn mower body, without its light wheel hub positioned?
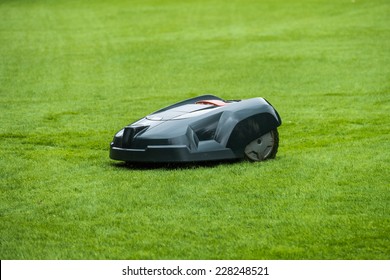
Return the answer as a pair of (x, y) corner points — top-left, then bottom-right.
(110, 95), (281, 163)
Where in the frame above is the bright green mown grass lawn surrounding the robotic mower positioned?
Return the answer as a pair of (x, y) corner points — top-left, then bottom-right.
(0, 0), (390, 259)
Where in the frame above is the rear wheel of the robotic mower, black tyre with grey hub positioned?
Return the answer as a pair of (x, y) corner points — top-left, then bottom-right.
(244, 128), (279, 161)
